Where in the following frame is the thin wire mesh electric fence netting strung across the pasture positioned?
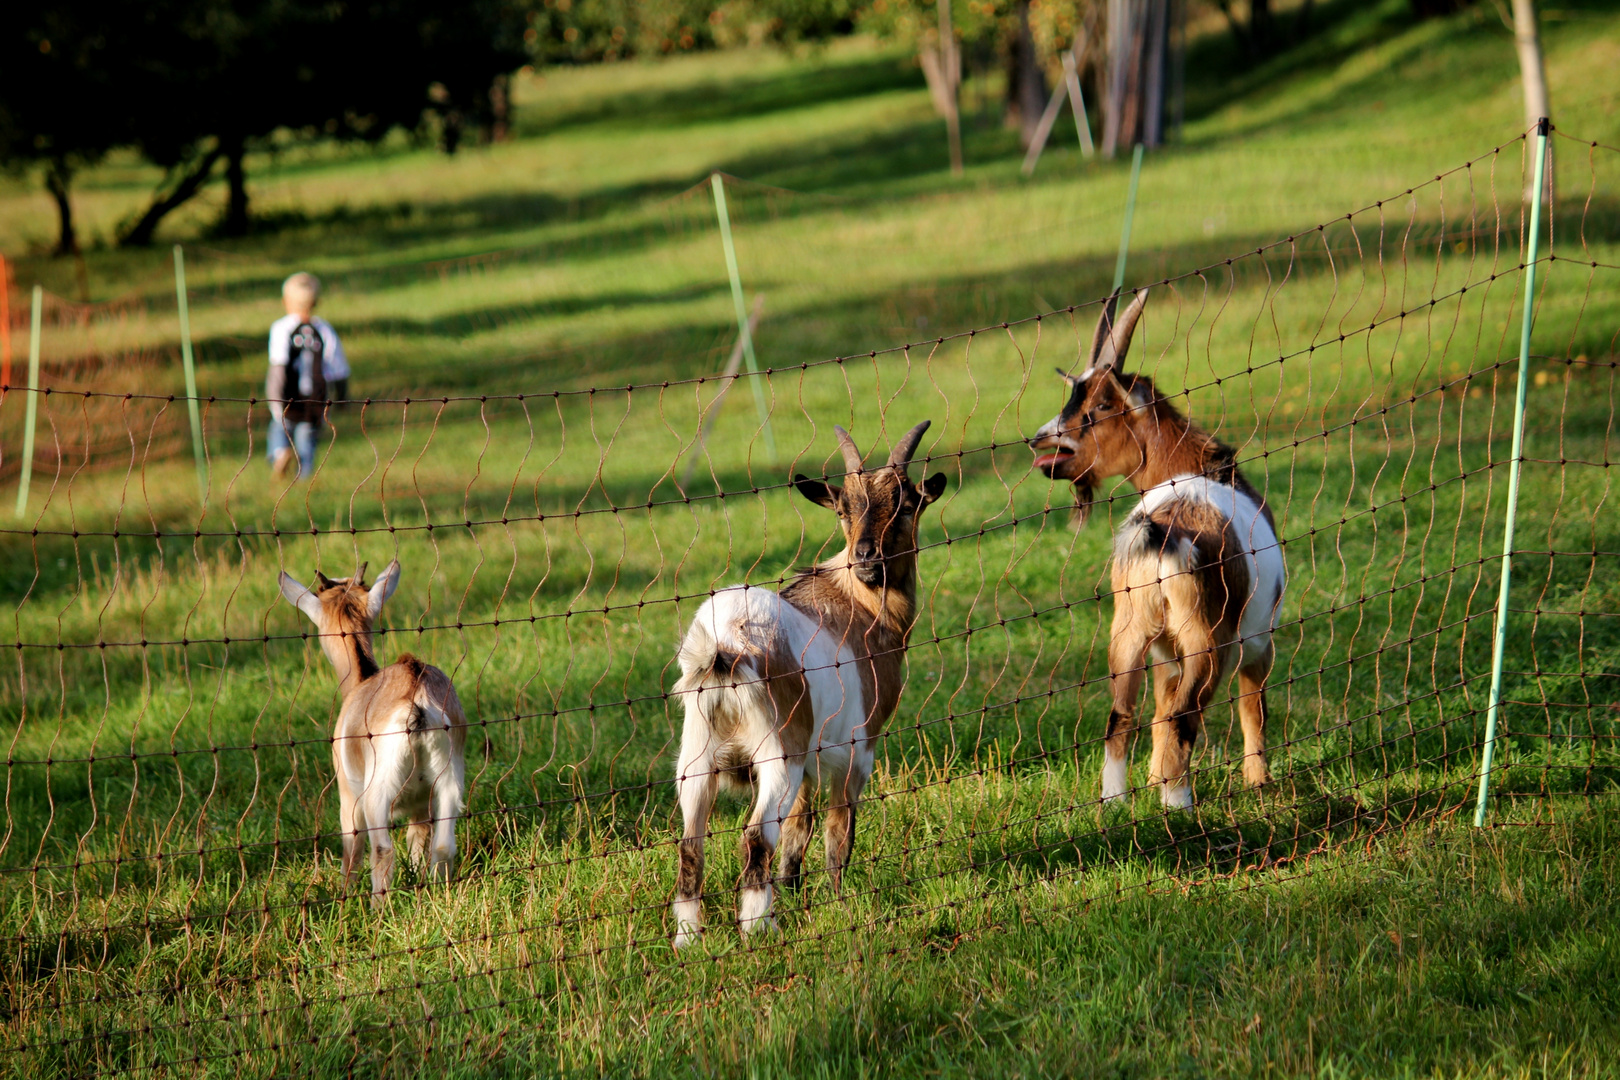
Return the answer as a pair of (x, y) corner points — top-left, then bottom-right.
(0, 133), (1620, 1075)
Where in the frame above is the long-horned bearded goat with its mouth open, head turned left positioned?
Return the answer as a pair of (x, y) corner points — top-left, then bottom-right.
(1029, 290), (1288, 808)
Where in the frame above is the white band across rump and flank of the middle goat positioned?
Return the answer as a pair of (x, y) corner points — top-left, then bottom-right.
(693, 585), (867, 764)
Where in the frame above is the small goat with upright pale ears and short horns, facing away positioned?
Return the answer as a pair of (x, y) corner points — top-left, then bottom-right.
(280, 560), (467, 904)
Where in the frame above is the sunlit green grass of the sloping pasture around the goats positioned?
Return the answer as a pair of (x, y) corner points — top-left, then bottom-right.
(0, 3), (1620, 1077)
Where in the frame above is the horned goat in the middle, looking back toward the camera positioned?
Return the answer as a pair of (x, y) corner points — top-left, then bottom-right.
(674, 421), (946, 949)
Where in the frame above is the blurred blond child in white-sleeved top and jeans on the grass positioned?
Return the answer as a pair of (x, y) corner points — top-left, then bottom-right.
(264, 272), (348, 479)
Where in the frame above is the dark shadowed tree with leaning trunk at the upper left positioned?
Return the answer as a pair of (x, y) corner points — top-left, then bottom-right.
(0, 0), (528, 249)
